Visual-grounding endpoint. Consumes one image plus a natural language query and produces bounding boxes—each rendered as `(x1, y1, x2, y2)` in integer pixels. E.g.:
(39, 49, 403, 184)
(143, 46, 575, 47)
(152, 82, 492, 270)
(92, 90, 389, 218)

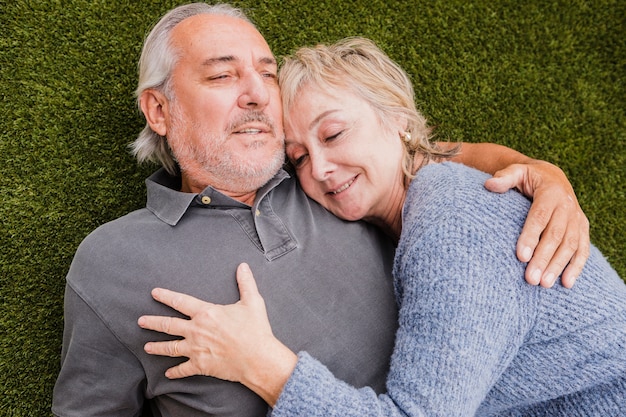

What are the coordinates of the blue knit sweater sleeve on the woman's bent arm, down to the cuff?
(273, 164, 533, 417)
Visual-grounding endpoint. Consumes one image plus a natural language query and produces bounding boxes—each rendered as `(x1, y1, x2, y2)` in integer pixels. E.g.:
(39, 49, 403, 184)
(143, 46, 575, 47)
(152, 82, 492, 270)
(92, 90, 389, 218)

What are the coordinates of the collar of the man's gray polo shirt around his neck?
(146, 168, 290, 226)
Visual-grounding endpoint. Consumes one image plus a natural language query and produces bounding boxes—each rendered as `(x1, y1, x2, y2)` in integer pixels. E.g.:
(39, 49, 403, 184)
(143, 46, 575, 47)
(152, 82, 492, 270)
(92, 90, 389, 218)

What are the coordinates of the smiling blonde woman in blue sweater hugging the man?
(140, 38, 626, 416)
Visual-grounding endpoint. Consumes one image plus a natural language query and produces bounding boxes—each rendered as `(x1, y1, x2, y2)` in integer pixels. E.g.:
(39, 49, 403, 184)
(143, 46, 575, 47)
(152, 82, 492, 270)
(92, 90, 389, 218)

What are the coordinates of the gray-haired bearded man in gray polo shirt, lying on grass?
(53, 4, 586, 417)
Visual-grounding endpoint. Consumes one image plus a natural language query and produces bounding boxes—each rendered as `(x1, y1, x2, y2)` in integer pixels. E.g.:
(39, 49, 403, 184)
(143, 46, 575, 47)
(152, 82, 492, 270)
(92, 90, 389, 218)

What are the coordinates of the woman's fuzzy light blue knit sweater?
(272, 163, 626, 417)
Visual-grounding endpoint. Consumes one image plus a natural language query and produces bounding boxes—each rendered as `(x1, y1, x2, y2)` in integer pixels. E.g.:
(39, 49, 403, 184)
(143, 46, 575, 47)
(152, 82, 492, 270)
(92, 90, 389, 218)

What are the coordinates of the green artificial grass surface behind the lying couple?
(0, 0, 626, 416)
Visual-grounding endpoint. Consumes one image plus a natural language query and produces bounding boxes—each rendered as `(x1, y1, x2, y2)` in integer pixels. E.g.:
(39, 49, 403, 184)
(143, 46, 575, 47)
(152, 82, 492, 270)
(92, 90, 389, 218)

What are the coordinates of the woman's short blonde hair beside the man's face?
(279, 37, 457, 184)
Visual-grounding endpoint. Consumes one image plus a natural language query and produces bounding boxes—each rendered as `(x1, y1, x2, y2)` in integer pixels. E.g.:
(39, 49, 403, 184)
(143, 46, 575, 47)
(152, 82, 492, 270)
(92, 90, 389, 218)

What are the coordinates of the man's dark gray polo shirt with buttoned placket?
(53, 170, 397, 417)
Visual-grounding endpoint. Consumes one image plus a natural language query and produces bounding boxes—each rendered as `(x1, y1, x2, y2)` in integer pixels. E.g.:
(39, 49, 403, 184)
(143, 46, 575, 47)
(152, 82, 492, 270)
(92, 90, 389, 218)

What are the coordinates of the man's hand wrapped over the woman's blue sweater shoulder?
(485, 160, 590, 288)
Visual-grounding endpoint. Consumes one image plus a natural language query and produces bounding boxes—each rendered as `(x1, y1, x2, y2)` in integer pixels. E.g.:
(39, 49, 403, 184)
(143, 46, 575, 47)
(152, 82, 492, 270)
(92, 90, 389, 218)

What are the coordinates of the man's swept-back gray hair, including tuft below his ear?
(131, 3, 252, 174)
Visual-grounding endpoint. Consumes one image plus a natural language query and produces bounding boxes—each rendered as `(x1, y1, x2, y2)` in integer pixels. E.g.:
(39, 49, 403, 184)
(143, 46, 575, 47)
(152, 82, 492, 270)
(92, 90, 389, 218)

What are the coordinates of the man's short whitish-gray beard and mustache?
(168, 109, 285, 193)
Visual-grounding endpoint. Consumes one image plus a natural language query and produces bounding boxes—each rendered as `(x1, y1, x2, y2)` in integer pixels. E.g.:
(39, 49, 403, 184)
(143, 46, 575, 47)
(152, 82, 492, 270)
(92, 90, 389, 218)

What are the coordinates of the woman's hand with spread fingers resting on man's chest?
(138, 264, 297, 406)
